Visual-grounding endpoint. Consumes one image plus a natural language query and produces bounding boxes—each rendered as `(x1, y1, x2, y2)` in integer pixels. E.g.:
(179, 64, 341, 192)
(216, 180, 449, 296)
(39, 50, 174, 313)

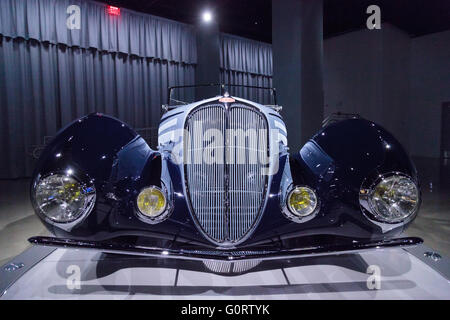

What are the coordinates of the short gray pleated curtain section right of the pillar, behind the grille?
(220, 34, 274, 104)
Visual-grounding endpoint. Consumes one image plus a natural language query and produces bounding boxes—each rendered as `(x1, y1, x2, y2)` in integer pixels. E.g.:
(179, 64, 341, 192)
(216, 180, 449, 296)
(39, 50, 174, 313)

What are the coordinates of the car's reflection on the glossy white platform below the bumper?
(48, 249, 415, 296)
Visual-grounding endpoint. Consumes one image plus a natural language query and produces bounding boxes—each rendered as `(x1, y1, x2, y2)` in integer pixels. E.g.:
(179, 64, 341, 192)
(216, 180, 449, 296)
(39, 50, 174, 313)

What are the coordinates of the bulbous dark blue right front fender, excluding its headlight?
(292, 119, 419, 238)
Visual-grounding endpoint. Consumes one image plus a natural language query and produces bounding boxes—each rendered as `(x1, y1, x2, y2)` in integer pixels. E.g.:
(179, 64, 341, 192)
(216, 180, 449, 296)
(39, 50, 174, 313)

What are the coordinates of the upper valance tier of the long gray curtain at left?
(0, 0, 197, 64)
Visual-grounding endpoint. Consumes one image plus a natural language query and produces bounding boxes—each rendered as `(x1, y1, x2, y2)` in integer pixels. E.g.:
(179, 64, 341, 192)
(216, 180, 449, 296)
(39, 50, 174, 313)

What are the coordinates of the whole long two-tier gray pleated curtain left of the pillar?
(0, 0, 196, 178)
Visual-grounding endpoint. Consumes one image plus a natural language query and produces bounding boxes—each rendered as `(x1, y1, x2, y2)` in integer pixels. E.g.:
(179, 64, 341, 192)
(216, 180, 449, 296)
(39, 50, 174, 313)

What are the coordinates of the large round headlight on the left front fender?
(34, 174, 95, 223)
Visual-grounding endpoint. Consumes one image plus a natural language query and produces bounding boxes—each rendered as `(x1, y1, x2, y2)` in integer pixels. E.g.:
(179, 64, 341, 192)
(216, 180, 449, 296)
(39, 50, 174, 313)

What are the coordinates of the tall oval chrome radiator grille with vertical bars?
(184, 104, 268, 243)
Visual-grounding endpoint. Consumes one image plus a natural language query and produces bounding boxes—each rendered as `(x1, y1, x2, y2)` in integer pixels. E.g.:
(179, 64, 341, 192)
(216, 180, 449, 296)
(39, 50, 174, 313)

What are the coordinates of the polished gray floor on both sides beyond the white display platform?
(0, 158, 450, 265)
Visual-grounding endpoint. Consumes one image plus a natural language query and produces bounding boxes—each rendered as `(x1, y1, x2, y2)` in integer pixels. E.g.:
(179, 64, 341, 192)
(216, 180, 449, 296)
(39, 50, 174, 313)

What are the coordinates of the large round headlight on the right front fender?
(369, 175, 419, 223)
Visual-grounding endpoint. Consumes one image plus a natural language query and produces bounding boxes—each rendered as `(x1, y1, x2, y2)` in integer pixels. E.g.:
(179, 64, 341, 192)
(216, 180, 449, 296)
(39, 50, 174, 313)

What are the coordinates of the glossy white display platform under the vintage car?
(0, 245, 450, 299)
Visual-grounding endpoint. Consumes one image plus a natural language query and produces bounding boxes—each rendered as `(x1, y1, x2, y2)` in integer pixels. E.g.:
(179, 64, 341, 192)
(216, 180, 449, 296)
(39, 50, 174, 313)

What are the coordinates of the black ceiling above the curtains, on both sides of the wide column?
(100, 0, 450, 42)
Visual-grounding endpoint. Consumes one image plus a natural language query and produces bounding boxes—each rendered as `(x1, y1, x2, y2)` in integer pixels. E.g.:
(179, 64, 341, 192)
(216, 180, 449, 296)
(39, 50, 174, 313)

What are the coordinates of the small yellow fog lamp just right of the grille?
(287, 187, 317, 217)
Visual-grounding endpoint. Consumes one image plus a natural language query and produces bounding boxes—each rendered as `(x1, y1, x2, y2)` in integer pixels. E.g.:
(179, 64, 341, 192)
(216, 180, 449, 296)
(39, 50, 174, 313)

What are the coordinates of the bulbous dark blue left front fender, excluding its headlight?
(31, 113, 161, 238)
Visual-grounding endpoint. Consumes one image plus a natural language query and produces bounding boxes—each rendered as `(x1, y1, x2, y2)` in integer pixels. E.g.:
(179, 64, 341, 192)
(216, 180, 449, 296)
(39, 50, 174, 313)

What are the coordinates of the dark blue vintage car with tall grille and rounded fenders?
(30, 86, 422, 260)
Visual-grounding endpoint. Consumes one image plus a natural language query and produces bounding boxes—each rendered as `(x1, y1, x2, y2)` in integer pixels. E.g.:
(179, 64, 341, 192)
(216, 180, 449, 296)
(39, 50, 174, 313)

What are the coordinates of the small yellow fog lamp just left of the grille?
(137, 186, 167, 218)
